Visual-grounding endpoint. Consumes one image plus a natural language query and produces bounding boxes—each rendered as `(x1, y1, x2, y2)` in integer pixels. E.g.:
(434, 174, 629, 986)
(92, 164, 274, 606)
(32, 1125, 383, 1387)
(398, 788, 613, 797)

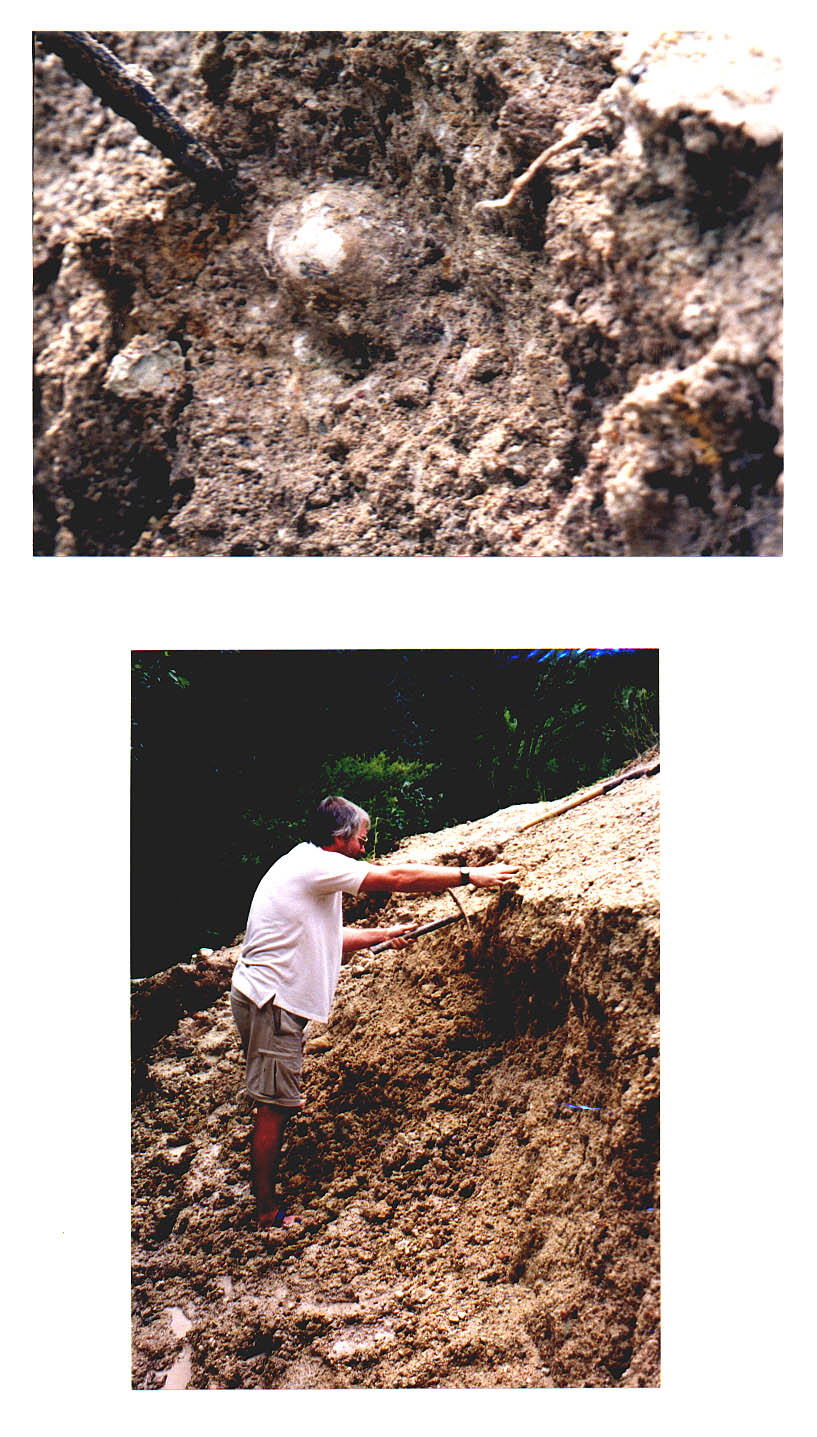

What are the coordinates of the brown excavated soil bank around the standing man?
(134, 776, 659, 1388)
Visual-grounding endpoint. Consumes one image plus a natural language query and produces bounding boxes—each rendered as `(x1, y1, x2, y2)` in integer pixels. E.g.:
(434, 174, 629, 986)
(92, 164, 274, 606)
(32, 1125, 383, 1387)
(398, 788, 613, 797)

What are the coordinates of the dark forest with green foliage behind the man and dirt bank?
(131, 650, 658, 977)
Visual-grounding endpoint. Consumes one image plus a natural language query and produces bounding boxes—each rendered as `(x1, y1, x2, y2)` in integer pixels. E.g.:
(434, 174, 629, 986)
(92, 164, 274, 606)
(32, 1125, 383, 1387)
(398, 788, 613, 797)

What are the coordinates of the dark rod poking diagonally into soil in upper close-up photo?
(34, 30, 241, 210)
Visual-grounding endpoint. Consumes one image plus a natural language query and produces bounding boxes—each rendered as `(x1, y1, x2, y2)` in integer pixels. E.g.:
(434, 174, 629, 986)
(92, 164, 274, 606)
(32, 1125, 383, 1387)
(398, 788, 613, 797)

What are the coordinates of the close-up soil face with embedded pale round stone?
(34, 32, 783, 556)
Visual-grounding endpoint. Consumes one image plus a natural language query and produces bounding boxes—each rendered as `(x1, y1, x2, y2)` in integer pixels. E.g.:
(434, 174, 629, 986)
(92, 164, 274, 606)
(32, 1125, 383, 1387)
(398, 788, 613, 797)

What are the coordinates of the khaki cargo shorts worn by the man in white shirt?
(230, 989, 307, 1109)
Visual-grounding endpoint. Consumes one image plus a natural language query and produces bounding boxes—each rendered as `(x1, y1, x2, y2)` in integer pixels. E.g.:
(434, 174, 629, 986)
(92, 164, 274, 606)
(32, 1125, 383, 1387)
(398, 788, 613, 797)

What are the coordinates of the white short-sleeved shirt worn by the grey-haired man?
(233, 844, 369, 1023)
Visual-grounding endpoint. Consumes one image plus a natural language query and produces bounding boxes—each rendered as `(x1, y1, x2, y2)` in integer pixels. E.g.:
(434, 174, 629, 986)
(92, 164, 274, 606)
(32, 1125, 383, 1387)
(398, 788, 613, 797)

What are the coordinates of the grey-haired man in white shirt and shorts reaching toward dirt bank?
(230, 798, 517, 1230)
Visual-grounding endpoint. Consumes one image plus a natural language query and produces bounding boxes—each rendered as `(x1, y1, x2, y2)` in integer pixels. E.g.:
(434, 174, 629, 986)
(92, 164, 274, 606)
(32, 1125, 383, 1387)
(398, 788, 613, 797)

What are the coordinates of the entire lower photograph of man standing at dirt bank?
(131, 648, 660, 1390)
